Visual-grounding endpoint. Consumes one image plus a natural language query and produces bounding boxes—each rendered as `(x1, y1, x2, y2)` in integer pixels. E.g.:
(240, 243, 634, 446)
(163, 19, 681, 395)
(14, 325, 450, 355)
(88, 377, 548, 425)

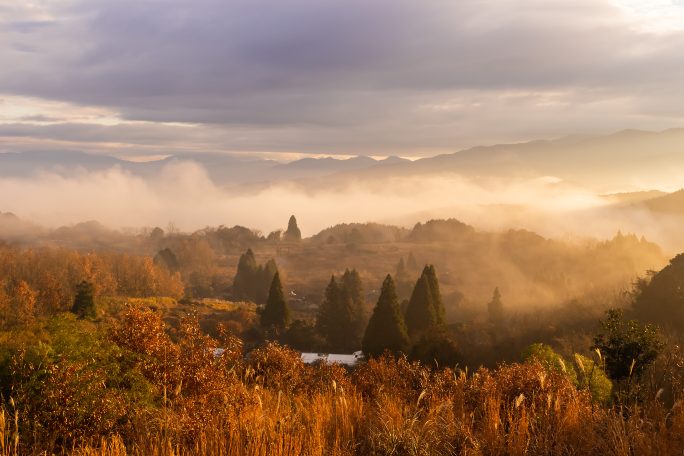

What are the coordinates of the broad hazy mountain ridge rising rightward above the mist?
(338, 129, 684, 192)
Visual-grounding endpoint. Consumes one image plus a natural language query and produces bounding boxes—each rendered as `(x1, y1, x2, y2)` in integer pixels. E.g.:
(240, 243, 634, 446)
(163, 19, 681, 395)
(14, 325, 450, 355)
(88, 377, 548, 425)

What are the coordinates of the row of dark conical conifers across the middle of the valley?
(233, 249, 460, 362)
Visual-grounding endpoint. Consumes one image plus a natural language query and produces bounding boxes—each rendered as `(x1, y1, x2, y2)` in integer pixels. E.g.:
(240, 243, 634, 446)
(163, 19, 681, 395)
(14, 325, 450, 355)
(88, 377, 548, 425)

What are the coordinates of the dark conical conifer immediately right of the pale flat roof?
(362, 274, 410, 356)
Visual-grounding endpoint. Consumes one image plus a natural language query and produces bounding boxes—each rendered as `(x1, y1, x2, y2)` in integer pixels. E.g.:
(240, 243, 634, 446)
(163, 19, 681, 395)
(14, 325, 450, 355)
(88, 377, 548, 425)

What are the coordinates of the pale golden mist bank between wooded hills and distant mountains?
(0, 161, 684, 251)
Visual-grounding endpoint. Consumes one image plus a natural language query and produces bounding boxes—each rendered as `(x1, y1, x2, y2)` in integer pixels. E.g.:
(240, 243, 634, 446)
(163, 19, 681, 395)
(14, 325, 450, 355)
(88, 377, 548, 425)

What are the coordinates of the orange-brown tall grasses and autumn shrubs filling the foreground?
(0, 309, 684, 456)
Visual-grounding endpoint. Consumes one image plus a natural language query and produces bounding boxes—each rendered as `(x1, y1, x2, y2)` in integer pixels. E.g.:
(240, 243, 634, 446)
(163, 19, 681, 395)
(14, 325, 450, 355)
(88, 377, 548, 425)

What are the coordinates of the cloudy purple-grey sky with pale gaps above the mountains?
(0, 0, 684, 157)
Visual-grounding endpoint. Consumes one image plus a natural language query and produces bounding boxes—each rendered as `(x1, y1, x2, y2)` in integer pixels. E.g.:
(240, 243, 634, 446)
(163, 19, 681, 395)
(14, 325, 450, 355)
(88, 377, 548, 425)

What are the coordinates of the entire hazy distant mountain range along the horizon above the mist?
(0, 129, 684, 193)
